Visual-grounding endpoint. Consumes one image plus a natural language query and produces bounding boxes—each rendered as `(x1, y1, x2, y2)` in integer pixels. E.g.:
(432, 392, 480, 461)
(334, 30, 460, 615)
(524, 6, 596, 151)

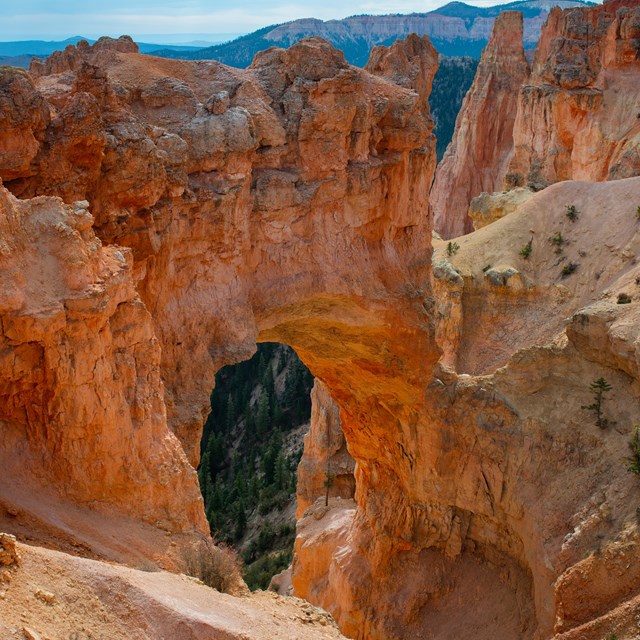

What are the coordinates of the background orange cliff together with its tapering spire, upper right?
(431, 0, 640, 238)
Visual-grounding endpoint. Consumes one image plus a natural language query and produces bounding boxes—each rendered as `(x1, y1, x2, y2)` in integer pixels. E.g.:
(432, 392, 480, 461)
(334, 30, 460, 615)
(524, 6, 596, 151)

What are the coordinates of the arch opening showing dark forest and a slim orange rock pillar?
(198, 343, 355, 593)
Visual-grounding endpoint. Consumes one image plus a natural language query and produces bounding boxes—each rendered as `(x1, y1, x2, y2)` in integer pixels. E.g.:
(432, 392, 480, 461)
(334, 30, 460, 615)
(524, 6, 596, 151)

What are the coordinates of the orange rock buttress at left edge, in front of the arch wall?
(0, 181, 206, 560)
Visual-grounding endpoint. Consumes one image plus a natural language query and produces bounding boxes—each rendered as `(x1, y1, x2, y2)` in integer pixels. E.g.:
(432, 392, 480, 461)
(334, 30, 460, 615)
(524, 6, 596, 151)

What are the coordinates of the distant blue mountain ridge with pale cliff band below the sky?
(155, 0, 593, 67)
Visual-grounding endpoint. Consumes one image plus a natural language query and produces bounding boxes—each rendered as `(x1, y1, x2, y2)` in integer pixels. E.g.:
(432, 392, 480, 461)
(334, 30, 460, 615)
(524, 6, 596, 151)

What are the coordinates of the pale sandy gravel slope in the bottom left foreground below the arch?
(0, 545, 344, 640)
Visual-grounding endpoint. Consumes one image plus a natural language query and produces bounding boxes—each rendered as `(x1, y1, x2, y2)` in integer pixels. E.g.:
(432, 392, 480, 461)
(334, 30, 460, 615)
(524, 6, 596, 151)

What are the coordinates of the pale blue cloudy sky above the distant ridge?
(0, 0, 499, 41)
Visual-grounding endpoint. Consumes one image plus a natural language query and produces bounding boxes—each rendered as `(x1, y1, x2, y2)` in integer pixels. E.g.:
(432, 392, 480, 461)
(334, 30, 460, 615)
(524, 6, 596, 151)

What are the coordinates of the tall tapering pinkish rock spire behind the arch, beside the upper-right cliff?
(431, 11, 529, 238)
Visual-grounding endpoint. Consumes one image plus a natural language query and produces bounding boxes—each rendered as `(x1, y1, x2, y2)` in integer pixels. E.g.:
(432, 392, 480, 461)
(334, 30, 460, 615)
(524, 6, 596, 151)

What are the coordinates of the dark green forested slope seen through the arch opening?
(198, 343, 313, 589)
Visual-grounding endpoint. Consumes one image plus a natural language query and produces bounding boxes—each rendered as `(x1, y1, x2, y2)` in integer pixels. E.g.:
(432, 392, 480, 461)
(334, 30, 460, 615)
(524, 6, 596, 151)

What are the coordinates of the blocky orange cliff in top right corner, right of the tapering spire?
(509, 0, 640, 188)
